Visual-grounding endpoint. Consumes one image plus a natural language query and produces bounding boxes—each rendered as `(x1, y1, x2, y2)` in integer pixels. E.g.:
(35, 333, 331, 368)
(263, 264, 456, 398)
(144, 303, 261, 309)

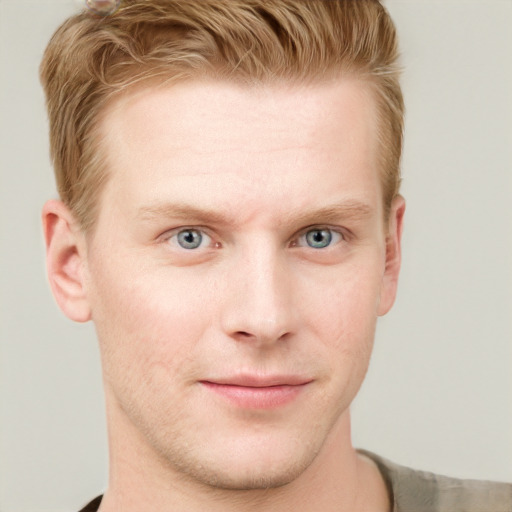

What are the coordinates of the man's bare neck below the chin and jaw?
(100, 404, 389, 512)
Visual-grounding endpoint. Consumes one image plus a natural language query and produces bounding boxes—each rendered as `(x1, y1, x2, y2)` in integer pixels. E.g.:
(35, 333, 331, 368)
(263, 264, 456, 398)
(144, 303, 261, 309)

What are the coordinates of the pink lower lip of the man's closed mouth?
(201, 382, 306, 409)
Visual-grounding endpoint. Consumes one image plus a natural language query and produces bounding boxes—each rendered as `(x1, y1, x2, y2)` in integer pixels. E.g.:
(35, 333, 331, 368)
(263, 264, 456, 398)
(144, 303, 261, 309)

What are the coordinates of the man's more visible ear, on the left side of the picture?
(42, 200, 91, 322)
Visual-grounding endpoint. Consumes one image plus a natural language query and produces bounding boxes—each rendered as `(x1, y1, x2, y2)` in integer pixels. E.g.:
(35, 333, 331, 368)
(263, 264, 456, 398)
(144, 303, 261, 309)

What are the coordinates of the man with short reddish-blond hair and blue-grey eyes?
(41, 0, 512, 512)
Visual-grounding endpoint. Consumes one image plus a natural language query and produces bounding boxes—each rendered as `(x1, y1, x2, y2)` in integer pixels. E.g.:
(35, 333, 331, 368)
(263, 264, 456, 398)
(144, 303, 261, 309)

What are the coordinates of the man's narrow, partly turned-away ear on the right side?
(377, 196, 405, 316)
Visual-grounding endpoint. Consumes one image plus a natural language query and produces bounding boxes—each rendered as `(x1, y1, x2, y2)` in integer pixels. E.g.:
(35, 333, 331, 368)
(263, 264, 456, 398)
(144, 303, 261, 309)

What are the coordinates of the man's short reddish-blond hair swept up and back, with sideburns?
(41, 0, 404, 230)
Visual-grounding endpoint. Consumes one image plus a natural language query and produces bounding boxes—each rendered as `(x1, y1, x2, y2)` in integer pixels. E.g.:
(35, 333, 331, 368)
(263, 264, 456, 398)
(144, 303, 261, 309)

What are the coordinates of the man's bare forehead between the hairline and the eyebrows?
(98, 79, 381, 222)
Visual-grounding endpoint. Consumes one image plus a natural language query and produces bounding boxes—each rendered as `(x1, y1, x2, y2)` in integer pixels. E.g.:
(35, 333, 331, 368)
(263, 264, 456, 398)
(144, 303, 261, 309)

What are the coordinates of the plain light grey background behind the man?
(0, 0, 512, 512)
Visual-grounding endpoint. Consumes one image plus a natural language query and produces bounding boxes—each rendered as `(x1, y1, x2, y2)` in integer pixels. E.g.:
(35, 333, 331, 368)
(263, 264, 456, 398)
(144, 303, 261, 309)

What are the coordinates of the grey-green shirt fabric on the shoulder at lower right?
(360, 450, 512, 512)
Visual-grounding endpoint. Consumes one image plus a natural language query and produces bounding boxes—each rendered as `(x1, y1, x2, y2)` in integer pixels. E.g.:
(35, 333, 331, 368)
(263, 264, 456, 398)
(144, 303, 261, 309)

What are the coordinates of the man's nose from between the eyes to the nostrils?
(222, 242, 297, 345)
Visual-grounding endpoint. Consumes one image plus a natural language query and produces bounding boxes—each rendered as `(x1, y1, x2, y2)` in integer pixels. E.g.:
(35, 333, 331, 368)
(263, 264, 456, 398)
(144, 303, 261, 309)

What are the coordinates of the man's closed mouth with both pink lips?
(200, 375, 312, 409)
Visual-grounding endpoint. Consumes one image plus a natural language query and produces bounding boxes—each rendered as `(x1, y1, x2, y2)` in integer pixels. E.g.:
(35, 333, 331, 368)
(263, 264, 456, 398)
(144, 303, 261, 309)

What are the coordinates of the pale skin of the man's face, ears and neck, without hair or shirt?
(43, 79, 405, 512)
